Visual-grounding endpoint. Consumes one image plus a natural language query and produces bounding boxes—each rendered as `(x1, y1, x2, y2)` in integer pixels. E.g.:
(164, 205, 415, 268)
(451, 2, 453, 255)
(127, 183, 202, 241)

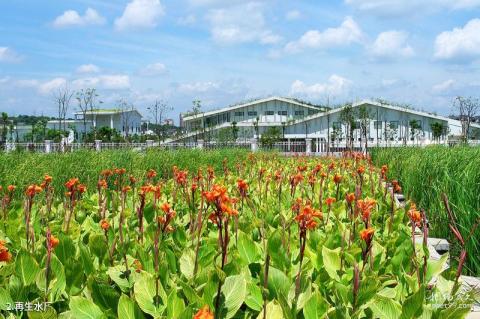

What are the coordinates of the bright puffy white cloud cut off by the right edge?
(435, 19, 480, 60)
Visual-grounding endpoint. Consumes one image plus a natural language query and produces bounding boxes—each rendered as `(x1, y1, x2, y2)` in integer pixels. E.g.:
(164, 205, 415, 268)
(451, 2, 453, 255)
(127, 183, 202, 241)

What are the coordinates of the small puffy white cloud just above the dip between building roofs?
(290, 74, 352, 99)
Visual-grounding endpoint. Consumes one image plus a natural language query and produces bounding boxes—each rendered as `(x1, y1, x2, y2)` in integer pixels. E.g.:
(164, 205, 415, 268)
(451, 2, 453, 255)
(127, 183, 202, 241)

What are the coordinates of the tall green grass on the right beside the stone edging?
(372, 146, 480, 275)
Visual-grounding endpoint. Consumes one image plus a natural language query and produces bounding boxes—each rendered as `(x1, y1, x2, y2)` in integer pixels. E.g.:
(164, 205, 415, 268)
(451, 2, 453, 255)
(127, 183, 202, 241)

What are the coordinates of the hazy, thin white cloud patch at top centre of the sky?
(207, 2, 281, 44)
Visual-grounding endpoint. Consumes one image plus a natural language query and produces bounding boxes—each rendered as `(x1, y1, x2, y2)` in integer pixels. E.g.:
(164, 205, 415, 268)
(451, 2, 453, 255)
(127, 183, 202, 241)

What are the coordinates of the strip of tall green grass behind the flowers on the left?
(0, 149, 248, 190)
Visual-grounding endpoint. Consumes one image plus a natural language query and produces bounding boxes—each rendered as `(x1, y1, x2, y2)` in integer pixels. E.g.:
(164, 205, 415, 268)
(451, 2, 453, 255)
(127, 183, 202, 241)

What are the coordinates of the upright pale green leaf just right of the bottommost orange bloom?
(221, 275, 247, 319)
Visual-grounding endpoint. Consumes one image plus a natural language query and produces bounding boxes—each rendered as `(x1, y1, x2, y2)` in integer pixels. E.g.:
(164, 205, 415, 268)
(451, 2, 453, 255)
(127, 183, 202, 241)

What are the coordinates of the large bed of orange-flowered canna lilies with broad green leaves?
(0, 153, 477, 319)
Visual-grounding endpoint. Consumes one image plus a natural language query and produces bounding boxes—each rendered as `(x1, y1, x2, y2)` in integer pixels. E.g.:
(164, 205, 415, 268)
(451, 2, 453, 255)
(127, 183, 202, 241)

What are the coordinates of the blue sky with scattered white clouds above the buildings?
(0, 0, 480, 120)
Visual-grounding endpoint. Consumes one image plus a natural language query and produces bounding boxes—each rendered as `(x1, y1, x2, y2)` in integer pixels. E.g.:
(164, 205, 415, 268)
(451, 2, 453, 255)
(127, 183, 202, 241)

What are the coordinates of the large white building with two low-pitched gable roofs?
(178, 97, 480, 145)
